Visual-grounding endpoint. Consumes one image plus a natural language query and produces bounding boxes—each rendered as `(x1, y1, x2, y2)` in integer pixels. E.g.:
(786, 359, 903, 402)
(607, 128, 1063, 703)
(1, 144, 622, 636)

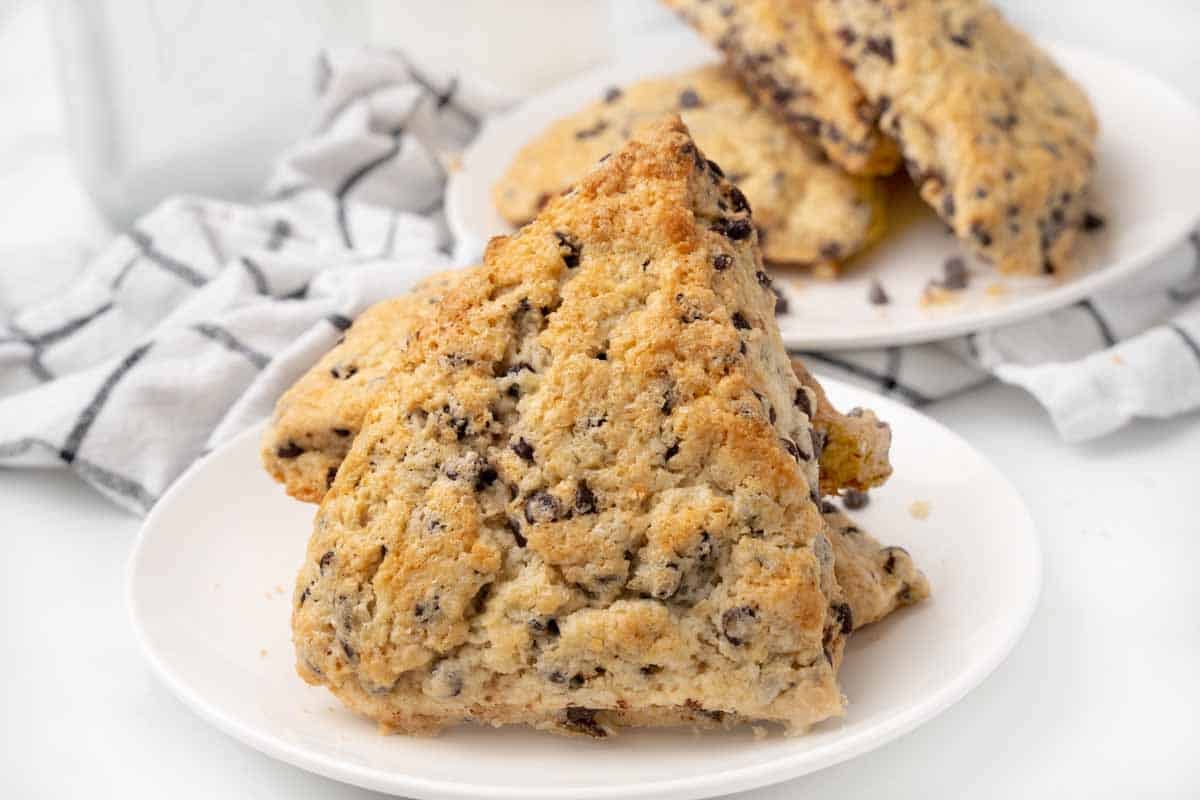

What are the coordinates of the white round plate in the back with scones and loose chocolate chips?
(446, 35, 1200, 350)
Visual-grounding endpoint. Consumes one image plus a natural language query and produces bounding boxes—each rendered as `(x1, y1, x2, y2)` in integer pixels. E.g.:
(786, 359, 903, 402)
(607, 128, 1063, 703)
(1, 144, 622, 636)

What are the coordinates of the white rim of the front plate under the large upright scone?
(125, 381, 1044, 800)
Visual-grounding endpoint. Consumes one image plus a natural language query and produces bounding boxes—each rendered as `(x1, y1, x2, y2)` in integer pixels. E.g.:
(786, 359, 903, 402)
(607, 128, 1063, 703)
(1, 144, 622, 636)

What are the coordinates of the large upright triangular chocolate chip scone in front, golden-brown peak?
(293, 119, 851, 736)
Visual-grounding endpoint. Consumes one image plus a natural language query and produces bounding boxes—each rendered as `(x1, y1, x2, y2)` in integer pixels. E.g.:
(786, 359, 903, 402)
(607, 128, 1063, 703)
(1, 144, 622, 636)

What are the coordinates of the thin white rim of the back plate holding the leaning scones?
(445, 37, 1200, 350)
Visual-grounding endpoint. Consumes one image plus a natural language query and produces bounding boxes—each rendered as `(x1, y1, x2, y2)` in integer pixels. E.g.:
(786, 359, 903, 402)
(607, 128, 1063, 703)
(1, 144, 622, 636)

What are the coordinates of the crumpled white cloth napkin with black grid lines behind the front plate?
(0, 50, 1200, 513)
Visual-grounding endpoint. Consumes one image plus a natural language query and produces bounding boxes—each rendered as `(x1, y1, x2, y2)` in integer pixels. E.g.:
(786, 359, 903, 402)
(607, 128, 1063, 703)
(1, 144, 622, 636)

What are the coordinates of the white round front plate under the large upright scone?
(128, 380, 1042, 800)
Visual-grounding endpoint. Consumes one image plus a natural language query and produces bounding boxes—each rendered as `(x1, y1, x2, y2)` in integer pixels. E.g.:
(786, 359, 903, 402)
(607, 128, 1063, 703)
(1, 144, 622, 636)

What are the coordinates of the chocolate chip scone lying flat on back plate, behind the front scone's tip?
(492, 66, 883, 267)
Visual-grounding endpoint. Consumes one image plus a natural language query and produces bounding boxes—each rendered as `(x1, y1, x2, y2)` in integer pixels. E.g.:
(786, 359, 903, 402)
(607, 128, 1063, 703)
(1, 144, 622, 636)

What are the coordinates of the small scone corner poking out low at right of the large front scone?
(822, 501, 929, 630)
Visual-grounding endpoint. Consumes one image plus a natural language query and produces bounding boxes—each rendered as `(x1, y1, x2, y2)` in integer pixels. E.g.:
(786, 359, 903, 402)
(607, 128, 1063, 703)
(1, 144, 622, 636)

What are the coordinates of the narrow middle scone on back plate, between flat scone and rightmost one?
(664, 0, 900, 175)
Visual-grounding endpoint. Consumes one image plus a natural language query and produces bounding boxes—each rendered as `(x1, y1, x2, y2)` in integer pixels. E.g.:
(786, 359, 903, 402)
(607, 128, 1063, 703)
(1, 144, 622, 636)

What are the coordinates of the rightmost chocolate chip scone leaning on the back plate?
(816, 0, 1097, 275)
